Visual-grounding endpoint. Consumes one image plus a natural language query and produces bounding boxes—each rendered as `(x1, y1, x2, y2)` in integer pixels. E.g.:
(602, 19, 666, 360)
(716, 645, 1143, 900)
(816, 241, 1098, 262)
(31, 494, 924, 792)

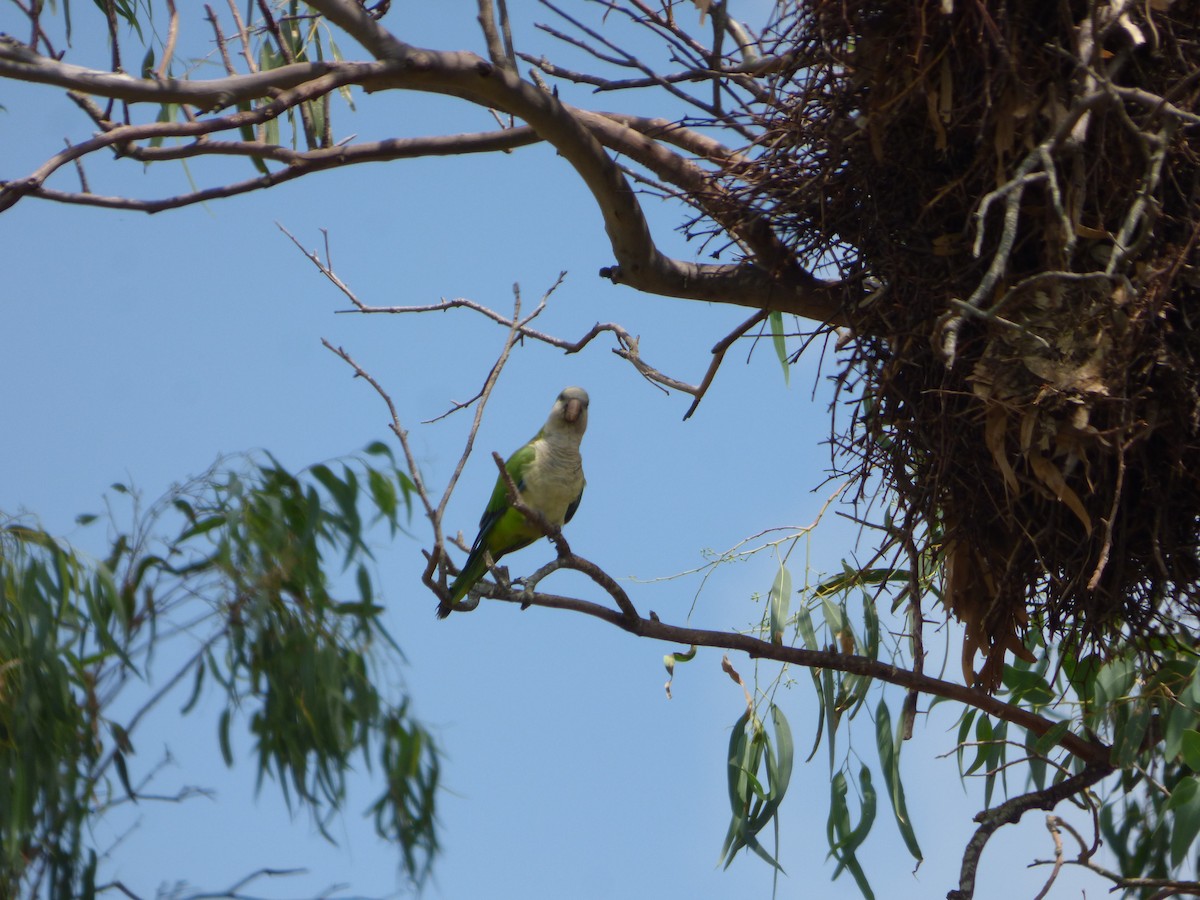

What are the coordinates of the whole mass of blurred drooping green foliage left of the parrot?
(0, 444, 439, 896)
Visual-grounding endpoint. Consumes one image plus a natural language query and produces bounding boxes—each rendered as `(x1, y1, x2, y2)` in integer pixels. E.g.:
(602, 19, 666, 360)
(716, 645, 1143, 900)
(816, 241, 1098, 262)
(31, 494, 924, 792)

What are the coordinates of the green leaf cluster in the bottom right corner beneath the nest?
(958, 638, 1200, 898)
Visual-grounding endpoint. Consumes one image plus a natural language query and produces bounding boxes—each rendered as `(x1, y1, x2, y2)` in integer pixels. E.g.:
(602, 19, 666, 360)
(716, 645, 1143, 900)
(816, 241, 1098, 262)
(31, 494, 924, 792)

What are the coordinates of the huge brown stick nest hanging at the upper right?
(752, 0, 1200, 688)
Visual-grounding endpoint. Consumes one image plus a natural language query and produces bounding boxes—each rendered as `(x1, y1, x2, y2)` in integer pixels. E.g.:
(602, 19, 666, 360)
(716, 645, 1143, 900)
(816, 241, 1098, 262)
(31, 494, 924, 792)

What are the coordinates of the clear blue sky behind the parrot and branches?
(0, 0, 1106, 900)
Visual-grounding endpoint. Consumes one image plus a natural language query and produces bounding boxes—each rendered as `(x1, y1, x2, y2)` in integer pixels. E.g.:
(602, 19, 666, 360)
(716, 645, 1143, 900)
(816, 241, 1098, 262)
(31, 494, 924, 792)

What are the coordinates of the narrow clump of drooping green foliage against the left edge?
(0, 524, 112, 896)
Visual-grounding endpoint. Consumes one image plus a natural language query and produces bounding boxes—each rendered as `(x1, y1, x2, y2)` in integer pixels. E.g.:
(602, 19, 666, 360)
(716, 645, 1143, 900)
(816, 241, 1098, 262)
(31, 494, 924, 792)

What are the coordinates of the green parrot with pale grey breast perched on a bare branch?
(438, 388, 588, 619)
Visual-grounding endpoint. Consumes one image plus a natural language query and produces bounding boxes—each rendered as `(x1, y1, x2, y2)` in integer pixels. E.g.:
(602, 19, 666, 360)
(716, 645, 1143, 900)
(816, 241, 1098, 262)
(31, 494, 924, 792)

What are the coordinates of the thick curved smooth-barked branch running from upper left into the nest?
(0, 0, 841, 323)
